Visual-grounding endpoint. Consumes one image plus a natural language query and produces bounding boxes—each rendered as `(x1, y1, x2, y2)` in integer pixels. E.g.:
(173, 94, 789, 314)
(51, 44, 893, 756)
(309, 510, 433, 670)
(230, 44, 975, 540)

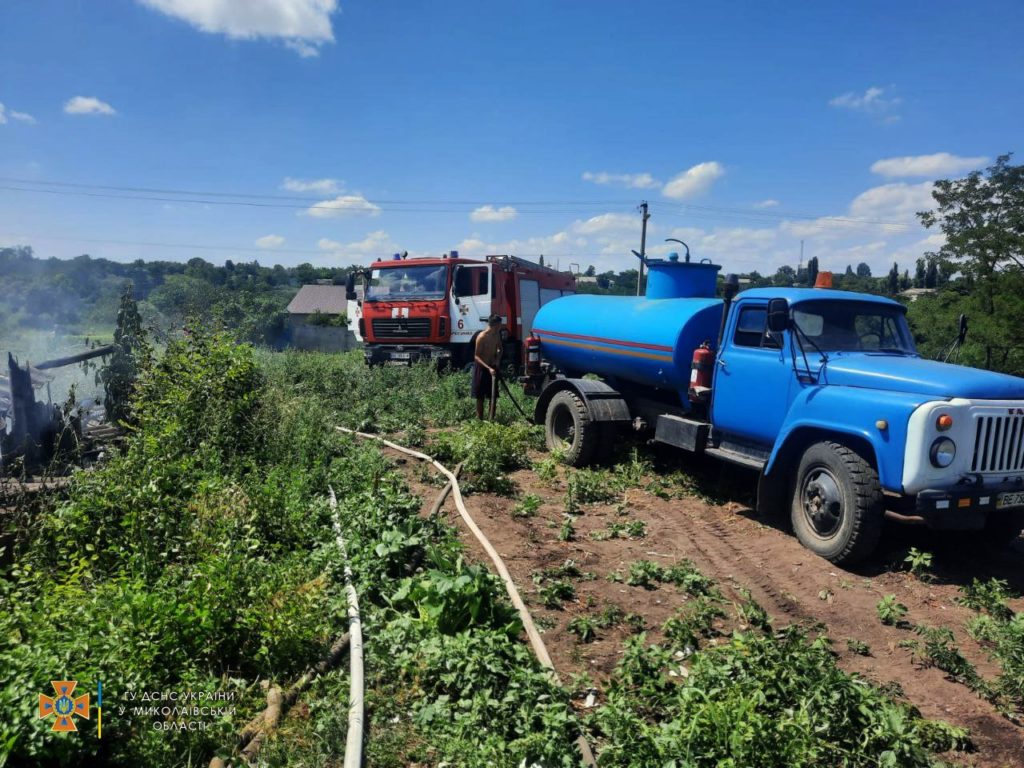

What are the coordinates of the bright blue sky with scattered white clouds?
(0, 0, 1024, 272)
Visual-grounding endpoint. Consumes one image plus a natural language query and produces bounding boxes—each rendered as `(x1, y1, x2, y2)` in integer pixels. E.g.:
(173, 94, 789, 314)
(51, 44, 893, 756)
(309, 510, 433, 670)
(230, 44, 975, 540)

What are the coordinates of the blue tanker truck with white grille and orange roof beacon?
(524, 254, 1024, 563)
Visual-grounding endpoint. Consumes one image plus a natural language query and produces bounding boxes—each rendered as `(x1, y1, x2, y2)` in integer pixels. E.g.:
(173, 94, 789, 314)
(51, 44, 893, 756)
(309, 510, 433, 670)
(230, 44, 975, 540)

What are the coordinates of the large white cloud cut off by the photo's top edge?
(137, 0, 338, 57)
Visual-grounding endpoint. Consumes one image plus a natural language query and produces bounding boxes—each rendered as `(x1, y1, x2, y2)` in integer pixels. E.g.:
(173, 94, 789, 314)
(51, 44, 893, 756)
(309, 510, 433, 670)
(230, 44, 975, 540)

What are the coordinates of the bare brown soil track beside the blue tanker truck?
(395, 455, 1024, 768)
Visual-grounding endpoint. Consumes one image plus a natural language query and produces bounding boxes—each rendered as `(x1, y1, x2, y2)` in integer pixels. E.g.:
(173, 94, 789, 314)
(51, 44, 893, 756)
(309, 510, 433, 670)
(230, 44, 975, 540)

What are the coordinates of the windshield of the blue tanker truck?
(793, 301, 916, 354)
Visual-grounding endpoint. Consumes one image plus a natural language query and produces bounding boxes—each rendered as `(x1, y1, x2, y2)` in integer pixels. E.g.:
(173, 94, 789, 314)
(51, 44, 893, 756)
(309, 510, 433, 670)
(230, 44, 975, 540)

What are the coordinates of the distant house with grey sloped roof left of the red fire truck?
(287, 285, 359, 352)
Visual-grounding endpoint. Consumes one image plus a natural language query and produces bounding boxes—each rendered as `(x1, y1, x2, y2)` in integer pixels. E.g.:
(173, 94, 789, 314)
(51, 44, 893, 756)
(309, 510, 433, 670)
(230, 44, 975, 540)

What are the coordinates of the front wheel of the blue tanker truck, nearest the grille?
(791, 441, 885, 565)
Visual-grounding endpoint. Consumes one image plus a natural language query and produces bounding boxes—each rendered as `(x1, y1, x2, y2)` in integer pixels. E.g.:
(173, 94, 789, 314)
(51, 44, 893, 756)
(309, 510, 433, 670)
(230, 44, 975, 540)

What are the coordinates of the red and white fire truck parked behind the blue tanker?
(347, 251, 575, 369)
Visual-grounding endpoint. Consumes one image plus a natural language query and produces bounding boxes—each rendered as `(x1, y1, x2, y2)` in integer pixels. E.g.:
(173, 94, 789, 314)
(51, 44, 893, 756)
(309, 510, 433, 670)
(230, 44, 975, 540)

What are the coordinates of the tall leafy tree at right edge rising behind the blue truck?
(918, 155, 1024, 373)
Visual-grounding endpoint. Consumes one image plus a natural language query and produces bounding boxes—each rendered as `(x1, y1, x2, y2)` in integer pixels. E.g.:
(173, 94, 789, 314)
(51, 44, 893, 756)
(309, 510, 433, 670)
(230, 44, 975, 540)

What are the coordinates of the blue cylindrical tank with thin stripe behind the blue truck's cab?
(534, 295, 723, 397)
